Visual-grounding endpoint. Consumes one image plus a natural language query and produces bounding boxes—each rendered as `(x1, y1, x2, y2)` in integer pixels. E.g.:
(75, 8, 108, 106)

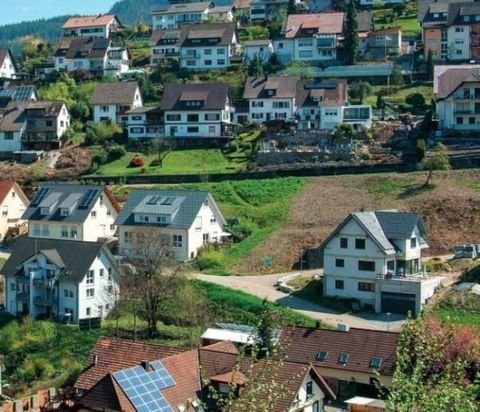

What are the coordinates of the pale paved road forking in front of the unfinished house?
(193, 270, 405, 330)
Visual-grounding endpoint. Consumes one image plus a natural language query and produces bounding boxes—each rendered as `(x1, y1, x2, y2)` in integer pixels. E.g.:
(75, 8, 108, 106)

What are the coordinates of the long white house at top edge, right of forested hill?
(152, 2, 214, 30)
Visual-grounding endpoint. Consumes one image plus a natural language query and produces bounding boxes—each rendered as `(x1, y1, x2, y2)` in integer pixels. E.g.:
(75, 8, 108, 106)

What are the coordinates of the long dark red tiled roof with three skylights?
(280, 326, 399, 376)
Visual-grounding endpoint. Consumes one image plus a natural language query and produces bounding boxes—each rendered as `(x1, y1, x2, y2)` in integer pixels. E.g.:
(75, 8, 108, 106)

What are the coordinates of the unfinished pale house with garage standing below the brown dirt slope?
(321, 210, 441, 315)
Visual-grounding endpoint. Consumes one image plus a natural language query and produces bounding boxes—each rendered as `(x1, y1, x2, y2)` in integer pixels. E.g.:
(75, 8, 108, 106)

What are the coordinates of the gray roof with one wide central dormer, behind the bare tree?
(115, 189, 225, 229)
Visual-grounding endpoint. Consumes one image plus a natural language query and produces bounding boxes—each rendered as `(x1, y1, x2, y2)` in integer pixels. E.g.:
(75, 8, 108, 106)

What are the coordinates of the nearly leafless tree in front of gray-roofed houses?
(127, 226, 181, 338)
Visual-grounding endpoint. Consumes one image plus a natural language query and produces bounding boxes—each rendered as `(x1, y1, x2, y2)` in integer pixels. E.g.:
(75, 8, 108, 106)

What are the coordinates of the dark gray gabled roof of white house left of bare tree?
(1, 237, 109, 282)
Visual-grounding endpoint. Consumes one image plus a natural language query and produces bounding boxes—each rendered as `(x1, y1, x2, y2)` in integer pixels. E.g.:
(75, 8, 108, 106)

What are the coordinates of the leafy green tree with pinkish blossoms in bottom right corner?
(387, 316, 480, 412)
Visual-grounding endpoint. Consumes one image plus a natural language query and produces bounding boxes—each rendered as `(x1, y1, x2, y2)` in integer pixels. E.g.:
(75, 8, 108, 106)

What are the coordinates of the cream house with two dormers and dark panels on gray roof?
(22, 183, 119, 242)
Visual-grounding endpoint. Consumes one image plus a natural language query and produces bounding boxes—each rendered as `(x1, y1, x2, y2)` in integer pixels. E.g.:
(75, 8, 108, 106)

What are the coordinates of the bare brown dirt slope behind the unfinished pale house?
(234, 171, 480, 274)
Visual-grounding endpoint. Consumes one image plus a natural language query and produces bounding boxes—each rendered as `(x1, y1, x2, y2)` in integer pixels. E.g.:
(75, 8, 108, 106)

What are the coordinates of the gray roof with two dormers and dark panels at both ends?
(22, 183, 108, 222)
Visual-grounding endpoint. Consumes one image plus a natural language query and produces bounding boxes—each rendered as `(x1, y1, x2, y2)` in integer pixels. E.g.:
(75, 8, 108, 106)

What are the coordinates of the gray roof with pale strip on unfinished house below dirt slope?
(320, 210, 426, 254)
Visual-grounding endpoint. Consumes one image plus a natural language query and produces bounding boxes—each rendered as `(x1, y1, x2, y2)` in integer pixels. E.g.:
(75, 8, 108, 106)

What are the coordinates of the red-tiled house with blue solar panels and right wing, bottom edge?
(75, 337, 335, 412)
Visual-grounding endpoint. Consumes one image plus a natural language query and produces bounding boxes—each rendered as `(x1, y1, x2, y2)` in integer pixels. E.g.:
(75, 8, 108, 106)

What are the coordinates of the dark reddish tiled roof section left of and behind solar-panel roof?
(74, 337, 186, 390)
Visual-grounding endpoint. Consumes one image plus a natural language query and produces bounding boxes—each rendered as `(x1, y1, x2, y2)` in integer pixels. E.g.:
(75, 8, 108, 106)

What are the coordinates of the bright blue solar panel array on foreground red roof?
(113, 361, 175, 412)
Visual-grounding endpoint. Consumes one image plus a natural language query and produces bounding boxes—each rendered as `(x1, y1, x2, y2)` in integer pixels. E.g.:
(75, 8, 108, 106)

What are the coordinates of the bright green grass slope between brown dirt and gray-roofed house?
(114, 177, 304, 274)
